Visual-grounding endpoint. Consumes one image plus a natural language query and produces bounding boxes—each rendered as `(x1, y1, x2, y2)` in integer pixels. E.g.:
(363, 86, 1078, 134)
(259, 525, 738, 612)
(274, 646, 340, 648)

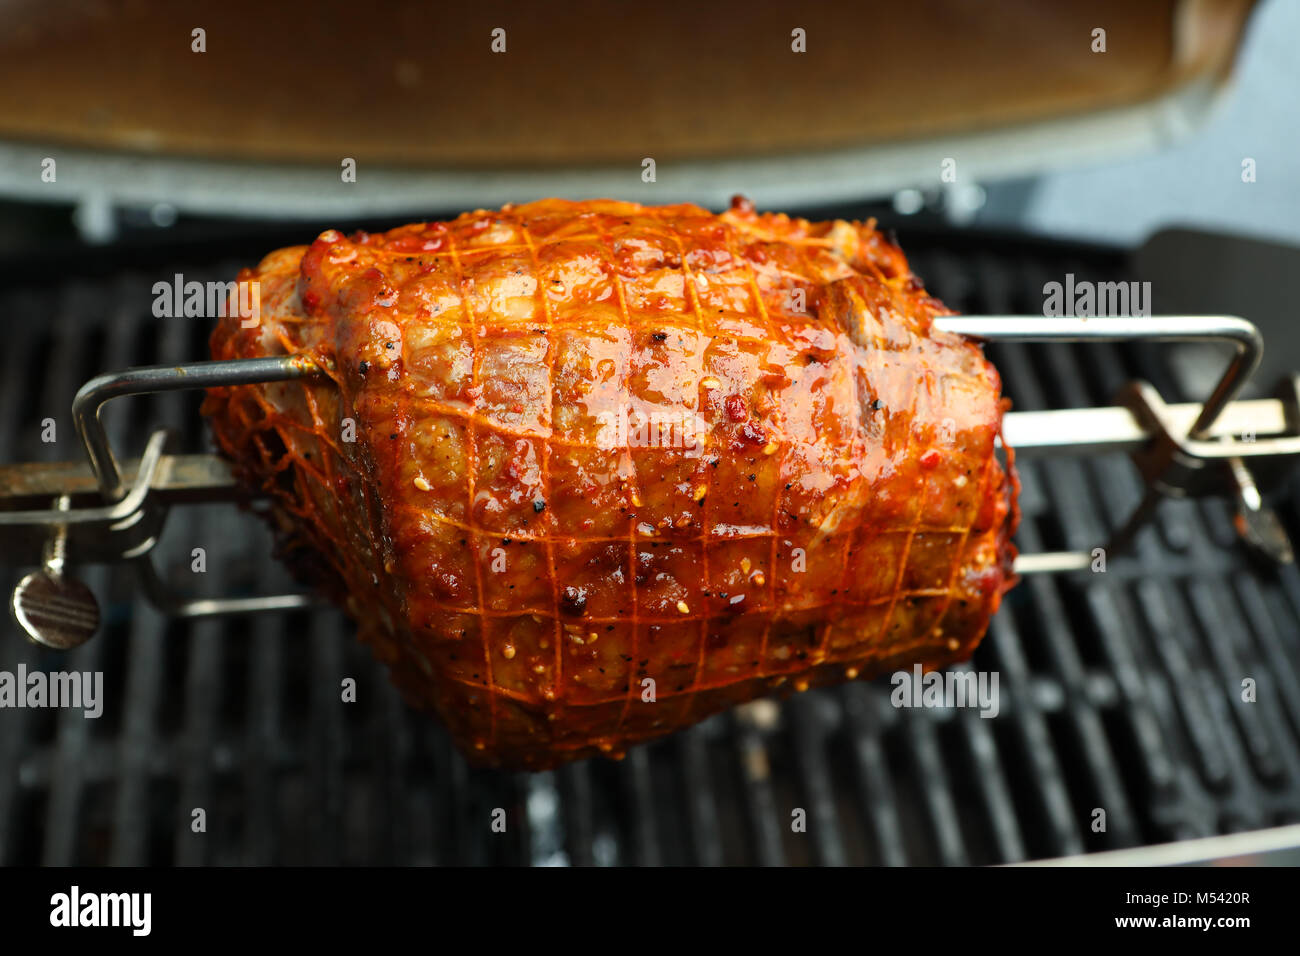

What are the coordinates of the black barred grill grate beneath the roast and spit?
(0, 226, 1300, 865)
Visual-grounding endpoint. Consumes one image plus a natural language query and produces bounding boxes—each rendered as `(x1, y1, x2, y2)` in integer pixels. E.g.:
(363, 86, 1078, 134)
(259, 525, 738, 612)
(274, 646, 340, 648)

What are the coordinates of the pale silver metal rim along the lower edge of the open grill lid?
(0, 77, 1226, 223)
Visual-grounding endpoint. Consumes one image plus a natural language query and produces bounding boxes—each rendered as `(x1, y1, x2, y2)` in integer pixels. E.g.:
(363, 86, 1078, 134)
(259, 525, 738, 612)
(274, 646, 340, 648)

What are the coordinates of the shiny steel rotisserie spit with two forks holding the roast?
(0, 316, 1300, 648)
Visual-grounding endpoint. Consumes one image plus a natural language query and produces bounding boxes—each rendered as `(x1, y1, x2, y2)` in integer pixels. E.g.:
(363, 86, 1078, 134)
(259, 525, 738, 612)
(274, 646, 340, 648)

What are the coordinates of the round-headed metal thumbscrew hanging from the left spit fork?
(9, 494, 99, 650)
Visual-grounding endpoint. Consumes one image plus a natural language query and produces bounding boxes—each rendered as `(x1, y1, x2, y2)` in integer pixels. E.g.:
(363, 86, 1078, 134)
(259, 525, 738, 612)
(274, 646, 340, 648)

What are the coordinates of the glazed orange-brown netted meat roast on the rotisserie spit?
(204, 200, 1018, 769)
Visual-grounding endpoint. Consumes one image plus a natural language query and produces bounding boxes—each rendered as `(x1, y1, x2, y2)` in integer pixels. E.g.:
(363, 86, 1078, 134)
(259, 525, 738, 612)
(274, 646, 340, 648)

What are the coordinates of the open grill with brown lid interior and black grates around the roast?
(0, 0, 1300, 874)
